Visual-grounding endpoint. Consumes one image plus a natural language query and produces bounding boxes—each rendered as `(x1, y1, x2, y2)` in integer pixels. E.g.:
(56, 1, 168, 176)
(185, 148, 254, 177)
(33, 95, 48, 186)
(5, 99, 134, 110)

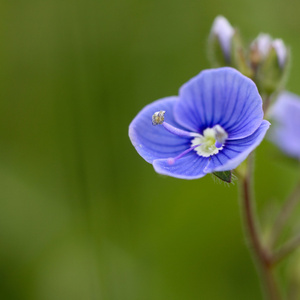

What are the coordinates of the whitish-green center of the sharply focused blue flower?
(192, 125, 228, 157)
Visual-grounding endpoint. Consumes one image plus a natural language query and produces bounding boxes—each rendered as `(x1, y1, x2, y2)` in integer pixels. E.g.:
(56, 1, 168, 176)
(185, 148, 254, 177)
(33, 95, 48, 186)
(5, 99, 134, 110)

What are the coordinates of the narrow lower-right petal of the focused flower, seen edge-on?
(204, 120, 270, 173)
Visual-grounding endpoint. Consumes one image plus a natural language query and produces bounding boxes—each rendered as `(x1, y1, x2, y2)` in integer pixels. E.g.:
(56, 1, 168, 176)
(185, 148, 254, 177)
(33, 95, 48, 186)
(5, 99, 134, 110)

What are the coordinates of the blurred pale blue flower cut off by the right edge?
(269, 92, 300, 159)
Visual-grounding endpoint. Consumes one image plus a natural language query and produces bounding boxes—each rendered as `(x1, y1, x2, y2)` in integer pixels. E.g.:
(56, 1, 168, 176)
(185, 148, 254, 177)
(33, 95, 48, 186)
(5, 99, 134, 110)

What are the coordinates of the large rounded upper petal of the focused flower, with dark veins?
(174, 68, 263, 139)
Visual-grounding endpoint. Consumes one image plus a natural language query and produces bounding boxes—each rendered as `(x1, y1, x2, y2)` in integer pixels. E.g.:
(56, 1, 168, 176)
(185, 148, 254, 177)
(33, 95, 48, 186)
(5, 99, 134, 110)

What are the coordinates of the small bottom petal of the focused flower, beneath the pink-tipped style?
(153, 151, 209, 179)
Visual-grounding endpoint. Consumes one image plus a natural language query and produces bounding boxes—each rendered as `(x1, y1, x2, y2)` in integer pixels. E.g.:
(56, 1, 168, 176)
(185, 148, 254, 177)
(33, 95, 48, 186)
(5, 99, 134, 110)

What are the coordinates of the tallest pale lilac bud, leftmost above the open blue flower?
(209, 16, 235, 66)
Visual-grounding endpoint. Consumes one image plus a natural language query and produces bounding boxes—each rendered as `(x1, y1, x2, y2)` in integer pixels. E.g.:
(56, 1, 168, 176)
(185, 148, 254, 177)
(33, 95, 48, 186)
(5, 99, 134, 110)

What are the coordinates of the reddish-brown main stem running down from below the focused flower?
(241, 154, 281, 300)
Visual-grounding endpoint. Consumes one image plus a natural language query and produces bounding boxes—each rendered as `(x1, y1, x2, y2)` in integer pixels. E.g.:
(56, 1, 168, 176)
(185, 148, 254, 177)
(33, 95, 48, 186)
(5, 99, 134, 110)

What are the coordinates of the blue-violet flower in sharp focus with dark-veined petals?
(129, 68, 270, 179)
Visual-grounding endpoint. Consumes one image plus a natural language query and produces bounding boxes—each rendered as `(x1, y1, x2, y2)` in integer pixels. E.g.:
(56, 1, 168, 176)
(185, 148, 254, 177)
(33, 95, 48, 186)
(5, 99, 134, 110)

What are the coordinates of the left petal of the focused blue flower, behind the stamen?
(129, 97, 190, 163)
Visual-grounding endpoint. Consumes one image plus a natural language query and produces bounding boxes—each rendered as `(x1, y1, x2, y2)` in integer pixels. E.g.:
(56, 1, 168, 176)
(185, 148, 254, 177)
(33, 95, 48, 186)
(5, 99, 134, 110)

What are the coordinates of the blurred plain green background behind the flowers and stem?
(0, 0, 300, 300)
